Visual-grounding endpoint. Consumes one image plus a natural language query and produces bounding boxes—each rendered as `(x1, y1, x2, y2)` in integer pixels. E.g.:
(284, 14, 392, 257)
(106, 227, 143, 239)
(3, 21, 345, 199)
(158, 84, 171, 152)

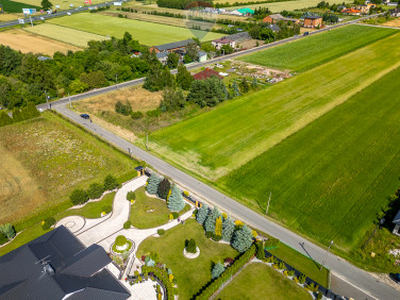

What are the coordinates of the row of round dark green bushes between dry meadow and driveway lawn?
(69, 175, 121, 205)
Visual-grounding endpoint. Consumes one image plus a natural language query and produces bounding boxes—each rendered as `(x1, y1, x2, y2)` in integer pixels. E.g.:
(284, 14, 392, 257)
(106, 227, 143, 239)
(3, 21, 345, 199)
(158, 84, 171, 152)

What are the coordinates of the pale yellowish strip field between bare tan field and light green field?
(25, 23, 108, 48)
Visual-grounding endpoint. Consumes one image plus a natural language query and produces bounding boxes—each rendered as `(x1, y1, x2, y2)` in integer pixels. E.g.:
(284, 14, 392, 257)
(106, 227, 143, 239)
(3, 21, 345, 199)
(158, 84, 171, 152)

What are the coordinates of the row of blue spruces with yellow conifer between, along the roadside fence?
(196, 204, 253, 252)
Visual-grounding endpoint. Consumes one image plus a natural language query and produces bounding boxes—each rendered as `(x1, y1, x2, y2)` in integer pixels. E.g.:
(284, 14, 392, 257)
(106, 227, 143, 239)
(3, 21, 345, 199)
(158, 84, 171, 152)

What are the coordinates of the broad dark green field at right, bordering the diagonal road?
(219, 68, 400, 251)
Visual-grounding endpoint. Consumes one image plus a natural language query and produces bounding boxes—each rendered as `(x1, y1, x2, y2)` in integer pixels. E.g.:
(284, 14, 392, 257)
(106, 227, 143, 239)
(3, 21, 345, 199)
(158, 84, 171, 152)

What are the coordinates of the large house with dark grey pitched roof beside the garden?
(0, 226, 130, 300)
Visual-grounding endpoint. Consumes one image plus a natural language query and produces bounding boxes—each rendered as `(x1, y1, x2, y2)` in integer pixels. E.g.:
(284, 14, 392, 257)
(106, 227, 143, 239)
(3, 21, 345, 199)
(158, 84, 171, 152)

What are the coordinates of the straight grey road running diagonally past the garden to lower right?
(53, 103, 400, 300)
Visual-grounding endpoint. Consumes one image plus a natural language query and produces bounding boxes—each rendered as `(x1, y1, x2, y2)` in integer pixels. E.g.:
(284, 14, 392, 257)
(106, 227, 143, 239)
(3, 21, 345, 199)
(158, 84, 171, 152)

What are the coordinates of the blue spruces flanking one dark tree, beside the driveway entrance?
(146, 172, 185, 212)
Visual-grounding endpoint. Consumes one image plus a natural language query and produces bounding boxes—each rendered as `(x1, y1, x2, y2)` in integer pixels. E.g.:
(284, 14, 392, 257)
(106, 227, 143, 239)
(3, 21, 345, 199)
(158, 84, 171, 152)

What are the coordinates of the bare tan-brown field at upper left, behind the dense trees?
(0, 29, 81, 55)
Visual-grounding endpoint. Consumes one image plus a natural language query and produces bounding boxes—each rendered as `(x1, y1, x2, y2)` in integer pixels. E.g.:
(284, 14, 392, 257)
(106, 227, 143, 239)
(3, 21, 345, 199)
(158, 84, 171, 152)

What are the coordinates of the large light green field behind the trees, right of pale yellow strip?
(49, 13, 222, 46)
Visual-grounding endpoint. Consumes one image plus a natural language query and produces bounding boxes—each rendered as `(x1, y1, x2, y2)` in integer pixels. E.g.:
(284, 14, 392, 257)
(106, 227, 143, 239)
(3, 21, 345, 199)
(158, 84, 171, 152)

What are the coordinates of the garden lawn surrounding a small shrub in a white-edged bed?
(136, 219, 239, 300)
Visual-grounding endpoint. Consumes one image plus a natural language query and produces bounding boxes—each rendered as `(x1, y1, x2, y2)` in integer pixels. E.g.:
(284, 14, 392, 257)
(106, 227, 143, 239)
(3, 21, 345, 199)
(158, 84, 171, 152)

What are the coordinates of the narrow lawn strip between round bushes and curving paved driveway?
(55, 192, 115, 221)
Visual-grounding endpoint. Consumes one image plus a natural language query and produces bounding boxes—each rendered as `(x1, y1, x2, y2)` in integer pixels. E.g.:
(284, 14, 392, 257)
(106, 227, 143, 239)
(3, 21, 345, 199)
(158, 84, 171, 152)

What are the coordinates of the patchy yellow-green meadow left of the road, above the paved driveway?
(0, 113, 135, 224)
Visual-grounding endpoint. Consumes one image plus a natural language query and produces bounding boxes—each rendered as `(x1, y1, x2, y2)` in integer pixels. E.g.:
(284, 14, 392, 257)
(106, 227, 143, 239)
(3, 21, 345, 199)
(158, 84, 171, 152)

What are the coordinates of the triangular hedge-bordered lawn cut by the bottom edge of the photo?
(216, 263, 312, 300)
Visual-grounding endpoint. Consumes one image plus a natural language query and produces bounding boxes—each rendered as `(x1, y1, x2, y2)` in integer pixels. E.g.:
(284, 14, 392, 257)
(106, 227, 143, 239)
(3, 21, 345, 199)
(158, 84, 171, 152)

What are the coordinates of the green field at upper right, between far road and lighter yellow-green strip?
(239, 25, 397, 72)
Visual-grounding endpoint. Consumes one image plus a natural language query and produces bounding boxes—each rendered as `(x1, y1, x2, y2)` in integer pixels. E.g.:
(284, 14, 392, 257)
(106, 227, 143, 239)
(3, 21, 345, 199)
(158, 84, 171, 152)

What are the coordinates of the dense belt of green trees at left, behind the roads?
(0, 32, 152, 109)
